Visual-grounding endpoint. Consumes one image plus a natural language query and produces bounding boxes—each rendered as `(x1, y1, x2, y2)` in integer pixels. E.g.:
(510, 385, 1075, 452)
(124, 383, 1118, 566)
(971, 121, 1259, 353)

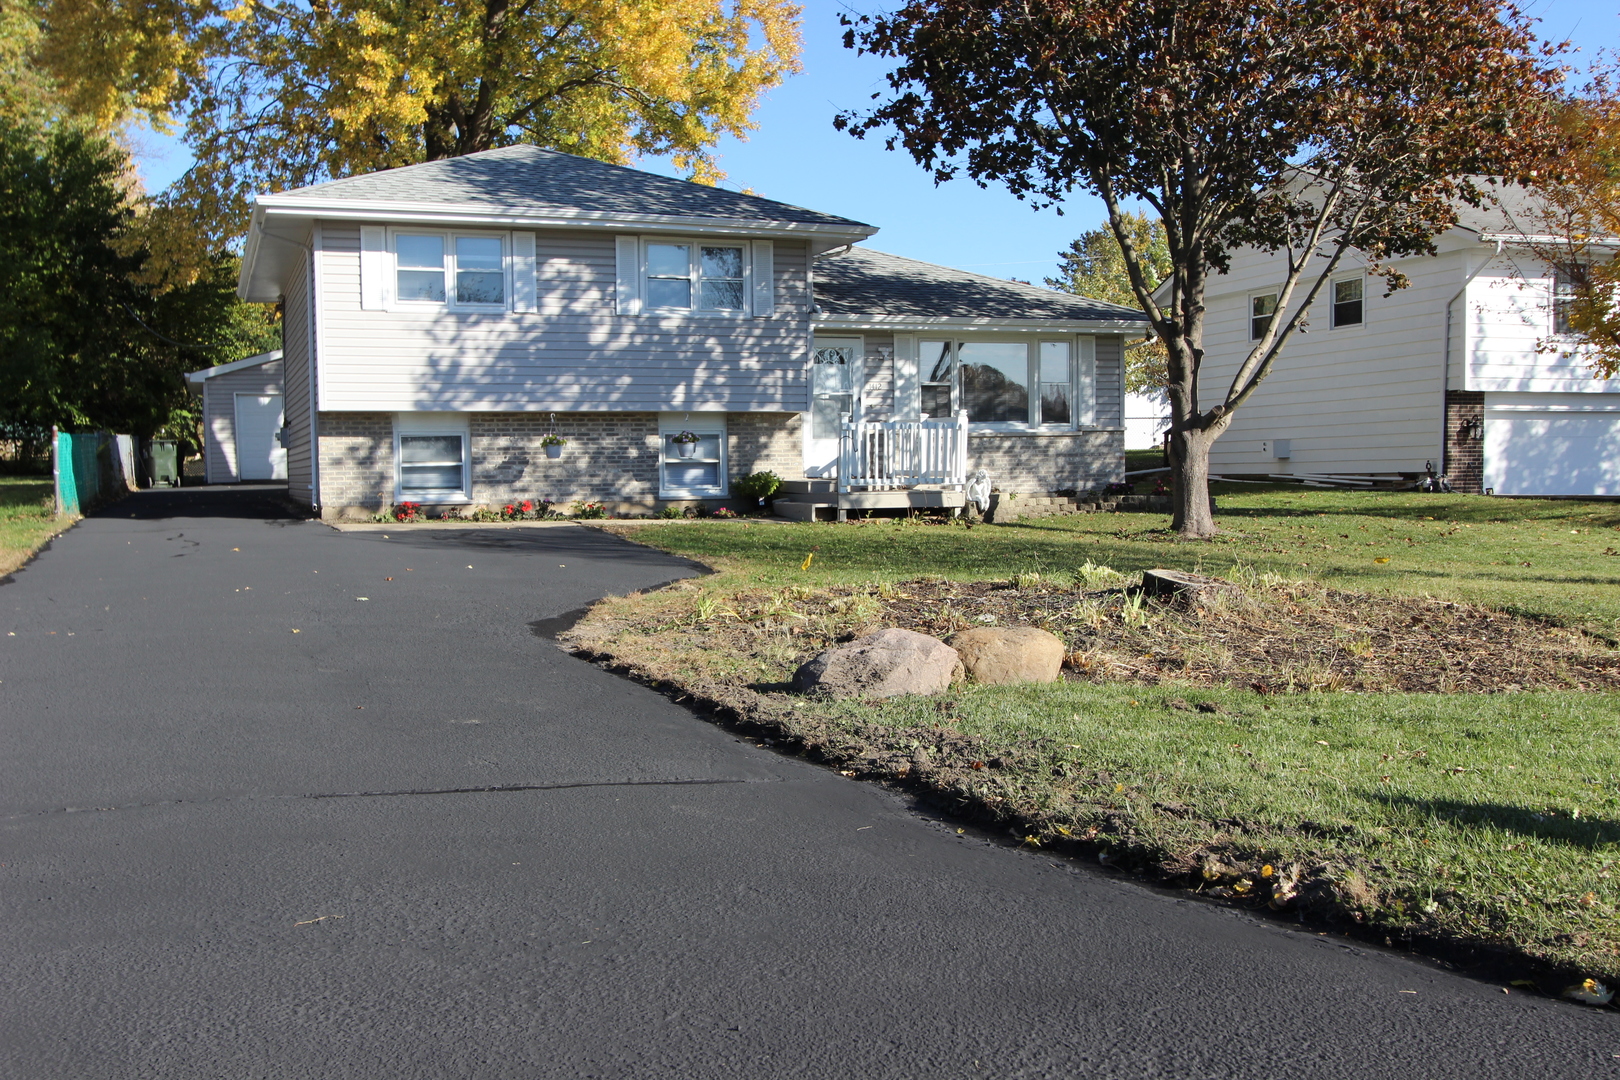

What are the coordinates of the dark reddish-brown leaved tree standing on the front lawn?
(836, 0, 1558, 538)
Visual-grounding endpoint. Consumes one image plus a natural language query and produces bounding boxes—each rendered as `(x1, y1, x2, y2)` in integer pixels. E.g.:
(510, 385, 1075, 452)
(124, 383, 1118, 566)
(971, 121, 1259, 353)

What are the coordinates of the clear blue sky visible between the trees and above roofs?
(136, 0, 1620, 283)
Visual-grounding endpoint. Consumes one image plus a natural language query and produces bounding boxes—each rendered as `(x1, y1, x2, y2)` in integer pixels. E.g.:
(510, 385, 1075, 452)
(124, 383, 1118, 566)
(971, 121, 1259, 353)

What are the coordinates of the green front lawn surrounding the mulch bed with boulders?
(582, 484, 1620, 984)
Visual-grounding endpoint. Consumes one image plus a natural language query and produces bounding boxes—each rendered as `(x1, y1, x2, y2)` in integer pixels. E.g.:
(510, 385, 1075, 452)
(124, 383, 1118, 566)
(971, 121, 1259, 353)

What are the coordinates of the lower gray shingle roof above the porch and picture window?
(815, 248, 1147, 322)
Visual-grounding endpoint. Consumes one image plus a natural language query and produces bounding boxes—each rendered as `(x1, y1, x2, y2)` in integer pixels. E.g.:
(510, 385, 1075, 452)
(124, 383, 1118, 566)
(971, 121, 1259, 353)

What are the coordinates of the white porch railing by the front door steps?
(838, 413, 967, 492)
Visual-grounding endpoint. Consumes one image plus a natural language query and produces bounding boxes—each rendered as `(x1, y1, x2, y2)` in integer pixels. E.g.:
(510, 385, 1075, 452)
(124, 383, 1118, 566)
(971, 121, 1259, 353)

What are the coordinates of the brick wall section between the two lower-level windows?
(470, 413, 658, 513)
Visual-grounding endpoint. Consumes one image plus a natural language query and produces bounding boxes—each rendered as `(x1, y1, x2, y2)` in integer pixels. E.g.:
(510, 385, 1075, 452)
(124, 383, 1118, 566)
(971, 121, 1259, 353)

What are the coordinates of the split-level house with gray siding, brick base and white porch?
(238, 146, 1144, 517)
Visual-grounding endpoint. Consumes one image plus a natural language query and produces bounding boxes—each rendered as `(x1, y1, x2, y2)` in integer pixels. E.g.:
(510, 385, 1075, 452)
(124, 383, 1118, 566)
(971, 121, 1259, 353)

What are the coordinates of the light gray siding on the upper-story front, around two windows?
(319, 225, 810, 413)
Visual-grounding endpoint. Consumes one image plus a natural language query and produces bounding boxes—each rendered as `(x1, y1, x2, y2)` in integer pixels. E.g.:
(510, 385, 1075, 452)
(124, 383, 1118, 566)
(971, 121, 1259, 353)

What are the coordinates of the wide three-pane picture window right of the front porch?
(919, 340, 1090, 429)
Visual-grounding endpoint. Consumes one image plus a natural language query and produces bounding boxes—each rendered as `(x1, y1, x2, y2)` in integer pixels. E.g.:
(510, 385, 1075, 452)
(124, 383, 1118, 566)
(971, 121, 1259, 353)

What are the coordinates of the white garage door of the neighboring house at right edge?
(1484, 408, 1620, 495)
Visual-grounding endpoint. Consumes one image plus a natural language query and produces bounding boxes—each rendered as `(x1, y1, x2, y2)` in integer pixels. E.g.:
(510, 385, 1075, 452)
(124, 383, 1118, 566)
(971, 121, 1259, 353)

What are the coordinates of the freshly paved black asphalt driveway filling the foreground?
(0, 489, 1620, 1080)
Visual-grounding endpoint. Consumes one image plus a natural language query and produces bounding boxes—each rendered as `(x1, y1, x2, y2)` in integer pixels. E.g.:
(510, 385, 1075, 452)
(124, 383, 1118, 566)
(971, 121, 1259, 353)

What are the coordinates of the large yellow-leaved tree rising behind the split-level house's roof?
(36, 0, 799, 257)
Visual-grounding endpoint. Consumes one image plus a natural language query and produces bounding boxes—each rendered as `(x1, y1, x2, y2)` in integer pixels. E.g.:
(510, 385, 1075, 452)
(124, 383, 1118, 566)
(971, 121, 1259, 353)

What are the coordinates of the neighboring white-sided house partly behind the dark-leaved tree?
(1200, 193, 1620, 495)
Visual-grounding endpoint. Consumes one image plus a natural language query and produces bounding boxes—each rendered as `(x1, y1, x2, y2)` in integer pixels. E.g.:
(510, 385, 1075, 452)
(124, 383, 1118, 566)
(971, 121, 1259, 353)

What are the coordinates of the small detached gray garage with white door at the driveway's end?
(186, 350, 287, 484)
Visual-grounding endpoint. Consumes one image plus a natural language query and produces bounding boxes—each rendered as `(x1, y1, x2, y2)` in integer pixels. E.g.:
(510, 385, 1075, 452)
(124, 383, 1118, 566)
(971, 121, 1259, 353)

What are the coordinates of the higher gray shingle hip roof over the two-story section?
(277, 146, 870, 228)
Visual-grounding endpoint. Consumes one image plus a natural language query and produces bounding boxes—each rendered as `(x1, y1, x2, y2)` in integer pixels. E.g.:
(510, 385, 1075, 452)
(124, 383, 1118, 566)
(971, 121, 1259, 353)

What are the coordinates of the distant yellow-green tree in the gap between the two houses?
(1047, 210, 1170, 395)
